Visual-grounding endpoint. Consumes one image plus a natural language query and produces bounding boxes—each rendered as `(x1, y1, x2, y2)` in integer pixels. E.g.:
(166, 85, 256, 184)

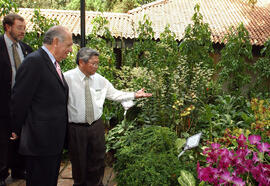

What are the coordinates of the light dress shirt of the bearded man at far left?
(4, 34, 24, 87)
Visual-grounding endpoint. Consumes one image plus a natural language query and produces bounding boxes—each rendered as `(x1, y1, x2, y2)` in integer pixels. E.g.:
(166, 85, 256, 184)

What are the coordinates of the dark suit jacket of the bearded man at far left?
(0, 35, 33, 120)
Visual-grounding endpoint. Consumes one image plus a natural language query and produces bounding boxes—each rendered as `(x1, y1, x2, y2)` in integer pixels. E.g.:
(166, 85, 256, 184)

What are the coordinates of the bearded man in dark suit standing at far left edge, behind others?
(0, 14, 33, 186)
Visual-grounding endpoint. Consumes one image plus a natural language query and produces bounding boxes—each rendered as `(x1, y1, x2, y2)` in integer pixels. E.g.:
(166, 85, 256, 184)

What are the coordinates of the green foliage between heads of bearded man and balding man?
(24, 10, 59, 50)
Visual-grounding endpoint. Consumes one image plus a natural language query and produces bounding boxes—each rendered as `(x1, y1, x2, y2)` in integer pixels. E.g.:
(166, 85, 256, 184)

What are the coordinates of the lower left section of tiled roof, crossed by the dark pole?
(16, 8, 134, 38)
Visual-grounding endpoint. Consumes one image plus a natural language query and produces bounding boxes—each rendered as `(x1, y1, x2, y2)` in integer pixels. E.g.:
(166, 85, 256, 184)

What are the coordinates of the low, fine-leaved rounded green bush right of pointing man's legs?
(114, 126, 184, 186)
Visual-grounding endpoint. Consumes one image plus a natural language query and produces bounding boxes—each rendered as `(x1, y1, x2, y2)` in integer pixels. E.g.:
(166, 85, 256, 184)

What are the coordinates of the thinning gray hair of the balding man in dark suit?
(43, 25, 68, 45)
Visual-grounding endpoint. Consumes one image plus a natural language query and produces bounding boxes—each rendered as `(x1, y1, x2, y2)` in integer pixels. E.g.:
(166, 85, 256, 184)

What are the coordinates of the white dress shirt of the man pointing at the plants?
(64, 67, 135, 123)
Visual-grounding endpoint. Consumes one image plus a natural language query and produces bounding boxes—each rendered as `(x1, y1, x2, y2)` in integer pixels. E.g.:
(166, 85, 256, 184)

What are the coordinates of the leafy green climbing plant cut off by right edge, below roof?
(254, 39, 270, 94)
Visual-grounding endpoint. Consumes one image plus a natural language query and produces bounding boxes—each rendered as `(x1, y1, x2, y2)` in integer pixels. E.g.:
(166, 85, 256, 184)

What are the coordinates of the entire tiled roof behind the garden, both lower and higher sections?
(5, 0, 270, 45)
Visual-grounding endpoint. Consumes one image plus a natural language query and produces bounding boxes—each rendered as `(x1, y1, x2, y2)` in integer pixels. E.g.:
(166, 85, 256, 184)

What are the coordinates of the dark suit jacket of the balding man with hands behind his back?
(11, 48, 68, 156)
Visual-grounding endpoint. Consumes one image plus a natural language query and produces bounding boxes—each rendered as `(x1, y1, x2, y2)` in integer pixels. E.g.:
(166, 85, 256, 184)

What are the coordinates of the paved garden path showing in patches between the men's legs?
(4, 161, 117, 186)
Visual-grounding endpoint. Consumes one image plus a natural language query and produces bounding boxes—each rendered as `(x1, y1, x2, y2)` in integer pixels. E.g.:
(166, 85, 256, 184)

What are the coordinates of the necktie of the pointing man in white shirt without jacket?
(84, 77, 94, 124)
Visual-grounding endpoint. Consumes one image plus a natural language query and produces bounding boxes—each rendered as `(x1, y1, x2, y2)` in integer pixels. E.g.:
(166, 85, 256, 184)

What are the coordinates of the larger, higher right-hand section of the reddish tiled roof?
(128, 0, 270, 45)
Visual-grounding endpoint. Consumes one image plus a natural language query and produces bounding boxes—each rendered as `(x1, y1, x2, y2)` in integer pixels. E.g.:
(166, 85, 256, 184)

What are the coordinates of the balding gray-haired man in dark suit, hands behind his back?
(11, 26, 73, 186)
